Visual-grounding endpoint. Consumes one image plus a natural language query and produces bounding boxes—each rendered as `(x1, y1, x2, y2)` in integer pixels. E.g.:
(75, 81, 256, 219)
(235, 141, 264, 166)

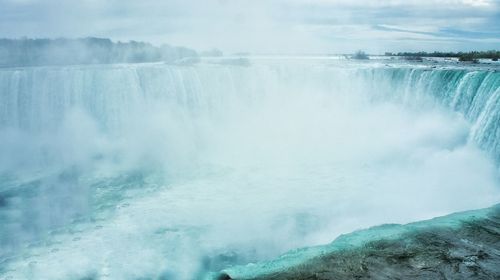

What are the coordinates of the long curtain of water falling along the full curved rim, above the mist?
(0, 60, 500, 162)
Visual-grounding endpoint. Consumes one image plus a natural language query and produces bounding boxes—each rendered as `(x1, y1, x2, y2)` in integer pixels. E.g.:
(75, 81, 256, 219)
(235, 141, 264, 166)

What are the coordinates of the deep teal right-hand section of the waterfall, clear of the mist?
(360, 68, 500, 162)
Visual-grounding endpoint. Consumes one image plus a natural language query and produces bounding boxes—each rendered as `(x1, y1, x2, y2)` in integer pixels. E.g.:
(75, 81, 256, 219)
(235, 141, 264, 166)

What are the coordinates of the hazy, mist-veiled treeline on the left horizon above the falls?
(0, 38, 198, 67)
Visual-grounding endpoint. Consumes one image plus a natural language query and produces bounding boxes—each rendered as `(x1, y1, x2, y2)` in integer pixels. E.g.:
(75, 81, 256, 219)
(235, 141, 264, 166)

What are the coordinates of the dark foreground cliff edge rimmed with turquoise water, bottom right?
(218, 204, 500, 280)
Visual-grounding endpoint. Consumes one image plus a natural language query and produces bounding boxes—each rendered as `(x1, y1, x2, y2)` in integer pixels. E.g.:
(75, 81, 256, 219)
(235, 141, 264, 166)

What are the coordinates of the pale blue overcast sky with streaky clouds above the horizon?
(0, 0, 500, 53)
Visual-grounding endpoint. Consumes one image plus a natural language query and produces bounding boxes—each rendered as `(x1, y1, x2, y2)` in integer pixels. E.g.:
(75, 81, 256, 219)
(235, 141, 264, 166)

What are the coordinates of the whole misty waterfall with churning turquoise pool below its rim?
(0, 59, 500, 279)
